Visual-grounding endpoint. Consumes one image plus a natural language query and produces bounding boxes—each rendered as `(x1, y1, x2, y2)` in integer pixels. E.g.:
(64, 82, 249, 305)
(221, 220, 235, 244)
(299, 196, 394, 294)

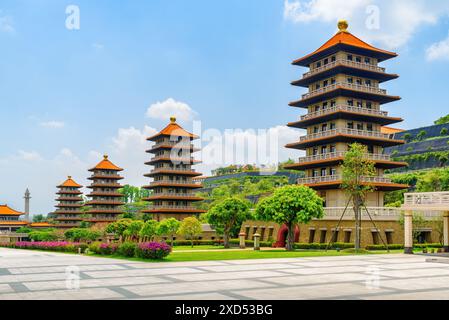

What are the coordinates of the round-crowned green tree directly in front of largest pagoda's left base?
(256, 185, 324, 251)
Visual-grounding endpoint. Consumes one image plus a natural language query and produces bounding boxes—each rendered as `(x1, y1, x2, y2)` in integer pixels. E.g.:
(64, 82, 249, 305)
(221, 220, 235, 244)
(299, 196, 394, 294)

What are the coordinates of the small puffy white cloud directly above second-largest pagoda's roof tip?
(146, 98, 196, 121)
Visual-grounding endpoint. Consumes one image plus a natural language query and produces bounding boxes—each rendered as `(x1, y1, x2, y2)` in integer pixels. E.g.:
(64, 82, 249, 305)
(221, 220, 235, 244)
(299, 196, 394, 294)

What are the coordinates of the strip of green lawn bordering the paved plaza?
(86, 250, 402, 263)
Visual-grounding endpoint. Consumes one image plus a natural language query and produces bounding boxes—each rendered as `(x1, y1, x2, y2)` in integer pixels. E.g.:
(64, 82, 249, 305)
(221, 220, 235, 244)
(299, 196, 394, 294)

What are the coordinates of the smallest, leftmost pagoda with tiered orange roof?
(54, 176, 83, 228)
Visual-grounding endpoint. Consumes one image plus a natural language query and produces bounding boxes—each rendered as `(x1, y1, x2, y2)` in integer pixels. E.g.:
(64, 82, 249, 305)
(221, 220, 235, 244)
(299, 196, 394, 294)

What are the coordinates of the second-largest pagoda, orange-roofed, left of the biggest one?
(143, 117, 205, 221)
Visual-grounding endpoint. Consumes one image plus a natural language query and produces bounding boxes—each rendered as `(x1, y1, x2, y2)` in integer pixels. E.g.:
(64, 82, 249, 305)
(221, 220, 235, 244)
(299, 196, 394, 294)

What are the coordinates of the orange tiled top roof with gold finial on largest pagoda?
(293, 21, 397, 64)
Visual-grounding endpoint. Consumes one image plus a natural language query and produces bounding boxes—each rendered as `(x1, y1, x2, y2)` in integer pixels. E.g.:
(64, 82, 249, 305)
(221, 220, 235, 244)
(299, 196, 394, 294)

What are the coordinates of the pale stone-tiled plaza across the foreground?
(0, 249, 449, 300)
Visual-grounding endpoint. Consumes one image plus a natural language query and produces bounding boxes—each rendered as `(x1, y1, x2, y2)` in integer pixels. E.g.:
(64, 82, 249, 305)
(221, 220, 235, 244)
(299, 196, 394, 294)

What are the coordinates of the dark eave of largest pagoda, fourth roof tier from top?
(287, 111, 404, 129)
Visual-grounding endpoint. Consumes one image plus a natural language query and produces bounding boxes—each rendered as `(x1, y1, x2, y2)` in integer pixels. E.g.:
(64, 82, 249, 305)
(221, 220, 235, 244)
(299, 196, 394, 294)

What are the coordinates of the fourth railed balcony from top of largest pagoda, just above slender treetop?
(286, 128, 405, 149)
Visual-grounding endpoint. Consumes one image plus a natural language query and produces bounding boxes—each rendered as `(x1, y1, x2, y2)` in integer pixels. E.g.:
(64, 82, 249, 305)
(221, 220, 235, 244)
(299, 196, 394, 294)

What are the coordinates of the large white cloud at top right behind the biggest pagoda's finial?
(284, 0, 449, 50)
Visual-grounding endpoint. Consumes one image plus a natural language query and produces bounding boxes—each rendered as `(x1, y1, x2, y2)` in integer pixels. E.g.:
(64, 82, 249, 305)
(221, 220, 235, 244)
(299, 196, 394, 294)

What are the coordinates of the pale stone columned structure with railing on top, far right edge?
(402, 192, 449, 254)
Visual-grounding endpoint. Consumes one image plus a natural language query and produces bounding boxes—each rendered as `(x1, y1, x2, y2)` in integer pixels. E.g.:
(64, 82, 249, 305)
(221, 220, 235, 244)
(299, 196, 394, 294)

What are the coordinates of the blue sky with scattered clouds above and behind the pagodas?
(0, 0, 449, 213)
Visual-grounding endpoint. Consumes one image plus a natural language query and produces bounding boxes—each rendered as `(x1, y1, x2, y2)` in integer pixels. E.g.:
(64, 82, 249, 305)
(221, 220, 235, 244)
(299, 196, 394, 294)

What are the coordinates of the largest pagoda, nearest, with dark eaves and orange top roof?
(286, 20, 408, 208)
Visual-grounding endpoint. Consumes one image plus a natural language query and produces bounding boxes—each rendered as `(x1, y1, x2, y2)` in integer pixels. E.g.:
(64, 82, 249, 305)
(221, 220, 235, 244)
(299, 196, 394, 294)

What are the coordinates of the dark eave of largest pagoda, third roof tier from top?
(289, 87, 401, 108)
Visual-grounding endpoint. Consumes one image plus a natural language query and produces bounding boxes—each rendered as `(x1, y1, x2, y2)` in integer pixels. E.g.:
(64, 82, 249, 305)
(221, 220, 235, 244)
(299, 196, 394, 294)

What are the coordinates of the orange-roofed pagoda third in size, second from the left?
(86, 155, 123, 223)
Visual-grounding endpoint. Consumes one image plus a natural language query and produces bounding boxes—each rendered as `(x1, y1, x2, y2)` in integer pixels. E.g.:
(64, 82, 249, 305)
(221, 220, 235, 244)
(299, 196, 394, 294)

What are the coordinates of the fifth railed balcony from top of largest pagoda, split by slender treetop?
(286, 151, 407, 170)
